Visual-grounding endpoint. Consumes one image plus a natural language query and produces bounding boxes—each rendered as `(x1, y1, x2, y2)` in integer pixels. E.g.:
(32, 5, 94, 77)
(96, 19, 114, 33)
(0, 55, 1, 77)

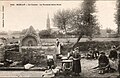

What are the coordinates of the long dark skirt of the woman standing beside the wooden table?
(72, 60, 81, 73)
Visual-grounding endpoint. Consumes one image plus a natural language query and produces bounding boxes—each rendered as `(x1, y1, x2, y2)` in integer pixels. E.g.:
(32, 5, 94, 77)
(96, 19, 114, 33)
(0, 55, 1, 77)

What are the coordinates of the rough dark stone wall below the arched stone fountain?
(5, 46, 47, 67)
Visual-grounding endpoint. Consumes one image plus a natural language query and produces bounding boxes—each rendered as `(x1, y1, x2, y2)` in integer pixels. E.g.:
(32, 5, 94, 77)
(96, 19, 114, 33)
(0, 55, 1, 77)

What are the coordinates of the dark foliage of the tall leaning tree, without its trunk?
(77, 0, 99, 37)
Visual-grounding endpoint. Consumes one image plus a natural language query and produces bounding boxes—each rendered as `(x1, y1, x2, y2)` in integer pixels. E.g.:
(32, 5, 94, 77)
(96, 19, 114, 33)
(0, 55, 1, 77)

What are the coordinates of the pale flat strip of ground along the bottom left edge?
(0, 71, 43, 78)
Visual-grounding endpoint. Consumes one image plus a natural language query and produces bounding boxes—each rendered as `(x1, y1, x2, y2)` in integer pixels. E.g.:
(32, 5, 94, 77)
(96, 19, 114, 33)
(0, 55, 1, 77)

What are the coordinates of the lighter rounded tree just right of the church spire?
(53, 10, 72, 33)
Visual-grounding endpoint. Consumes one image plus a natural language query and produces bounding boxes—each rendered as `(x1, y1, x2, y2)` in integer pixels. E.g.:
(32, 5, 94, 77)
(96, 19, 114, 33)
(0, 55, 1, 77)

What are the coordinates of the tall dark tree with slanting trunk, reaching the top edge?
(72, 0, 100, 47)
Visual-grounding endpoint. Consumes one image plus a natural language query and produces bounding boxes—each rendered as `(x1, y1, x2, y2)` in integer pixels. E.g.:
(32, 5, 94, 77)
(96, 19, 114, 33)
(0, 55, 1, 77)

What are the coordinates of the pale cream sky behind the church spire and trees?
(0, 0, 117, 31)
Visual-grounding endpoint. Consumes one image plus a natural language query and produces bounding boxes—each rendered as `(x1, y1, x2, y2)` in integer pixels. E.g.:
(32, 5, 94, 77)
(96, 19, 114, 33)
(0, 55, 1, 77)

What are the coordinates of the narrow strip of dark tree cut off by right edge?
(115, 0, 120, 35)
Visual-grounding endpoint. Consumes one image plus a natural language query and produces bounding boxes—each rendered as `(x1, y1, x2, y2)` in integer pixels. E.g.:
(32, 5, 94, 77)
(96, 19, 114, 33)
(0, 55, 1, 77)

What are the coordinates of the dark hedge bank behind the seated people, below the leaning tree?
(62, 41, 120, 54)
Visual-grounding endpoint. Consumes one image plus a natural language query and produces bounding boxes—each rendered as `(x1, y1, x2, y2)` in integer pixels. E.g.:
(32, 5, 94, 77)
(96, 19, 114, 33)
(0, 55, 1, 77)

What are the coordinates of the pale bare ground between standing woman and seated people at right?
(81, 59, 118, 78)
